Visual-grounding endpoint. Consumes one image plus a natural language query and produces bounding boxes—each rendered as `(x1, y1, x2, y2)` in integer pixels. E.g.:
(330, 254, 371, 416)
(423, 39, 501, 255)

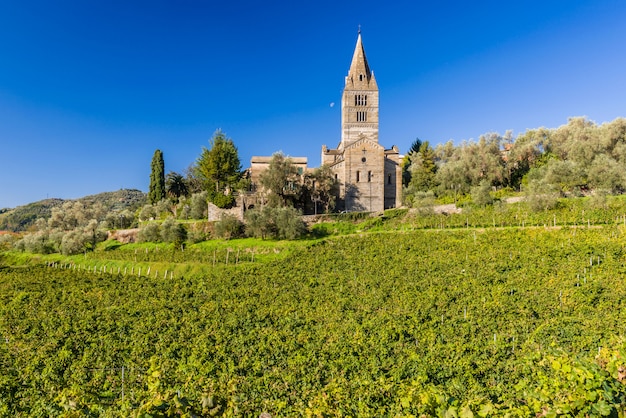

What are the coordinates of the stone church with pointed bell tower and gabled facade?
(322, 31, 402, 211)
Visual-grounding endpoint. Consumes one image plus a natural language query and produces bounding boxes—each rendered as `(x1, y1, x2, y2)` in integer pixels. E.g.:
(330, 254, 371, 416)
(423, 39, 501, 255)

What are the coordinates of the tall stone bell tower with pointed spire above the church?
(339, 29, 378, 149)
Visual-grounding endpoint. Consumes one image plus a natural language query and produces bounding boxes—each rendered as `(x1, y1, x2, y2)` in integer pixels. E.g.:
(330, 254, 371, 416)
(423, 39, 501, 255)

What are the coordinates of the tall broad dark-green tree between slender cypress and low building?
(191, 130, 241, 207)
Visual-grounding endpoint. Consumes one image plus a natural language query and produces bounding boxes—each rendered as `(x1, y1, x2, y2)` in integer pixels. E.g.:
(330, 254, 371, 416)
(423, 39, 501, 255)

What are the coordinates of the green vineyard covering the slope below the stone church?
(0, 222, 626, 417)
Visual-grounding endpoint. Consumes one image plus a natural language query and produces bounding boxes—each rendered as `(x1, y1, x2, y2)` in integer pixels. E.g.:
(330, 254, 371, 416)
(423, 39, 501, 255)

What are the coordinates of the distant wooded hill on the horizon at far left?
(0, 189, 146, 232)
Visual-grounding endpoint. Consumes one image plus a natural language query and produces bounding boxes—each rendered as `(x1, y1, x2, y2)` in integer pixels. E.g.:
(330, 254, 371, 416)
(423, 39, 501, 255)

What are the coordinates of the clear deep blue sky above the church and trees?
(0, 0, 626, 208)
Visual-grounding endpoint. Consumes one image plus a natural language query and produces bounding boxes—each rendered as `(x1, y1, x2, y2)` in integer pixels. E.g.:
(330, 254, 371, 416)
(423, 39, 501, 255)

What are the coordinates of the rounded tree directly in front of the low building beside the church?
(259, 152, 302, 207)
